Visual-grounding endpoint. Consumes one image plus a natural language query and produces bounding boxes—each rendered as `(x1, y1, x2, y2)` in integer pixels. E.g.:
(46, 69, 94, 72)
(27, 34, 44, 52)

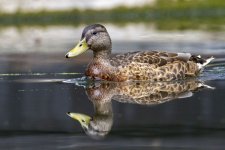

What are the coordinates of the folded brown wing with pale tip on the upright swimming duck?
(110, 51, 192, 66)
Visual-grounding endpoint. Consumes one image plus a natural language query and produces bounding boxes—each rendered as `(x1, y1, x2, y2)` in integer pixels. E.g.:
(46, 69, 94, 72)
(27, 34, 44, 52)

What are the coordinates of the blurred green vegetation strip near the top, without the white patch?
(0, 0, 225, 30)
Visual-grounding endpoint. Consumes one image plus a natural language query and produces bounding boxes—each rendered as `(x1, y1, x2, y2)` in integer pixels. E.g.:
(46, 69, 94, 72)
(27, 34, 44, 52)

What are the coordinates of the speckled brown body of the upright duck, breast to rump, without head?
(86, 51, 211, 81)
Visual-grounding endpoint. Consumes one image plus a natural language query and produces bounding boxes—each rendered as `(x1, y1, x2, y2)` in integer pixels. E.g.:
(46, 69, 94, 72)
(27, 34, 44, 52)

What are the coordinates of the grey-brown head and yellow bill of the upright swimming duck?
(66, 24, 112, 58)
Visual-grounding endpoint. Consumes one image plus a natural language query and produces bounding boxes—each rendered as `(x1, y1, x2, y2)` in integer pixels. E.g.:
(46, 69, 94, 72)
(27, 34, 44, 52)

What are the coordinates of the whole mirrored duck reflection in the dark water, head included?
(68, 79, 212, 138)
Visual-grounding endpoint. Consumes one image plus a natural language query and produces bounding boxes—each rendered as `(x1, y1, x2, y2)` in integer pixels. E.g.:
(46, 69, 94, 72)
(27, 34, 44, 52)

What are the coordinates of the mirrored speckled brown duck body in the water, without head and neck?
(86, 79, 208, 105)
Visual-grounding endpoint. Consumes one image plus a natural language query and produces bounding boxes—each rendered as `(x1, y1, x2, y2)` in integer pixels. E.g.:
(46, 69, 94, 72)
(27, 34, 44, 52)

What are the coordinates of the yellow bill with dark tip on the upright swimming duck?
(66, 38, 89, 58)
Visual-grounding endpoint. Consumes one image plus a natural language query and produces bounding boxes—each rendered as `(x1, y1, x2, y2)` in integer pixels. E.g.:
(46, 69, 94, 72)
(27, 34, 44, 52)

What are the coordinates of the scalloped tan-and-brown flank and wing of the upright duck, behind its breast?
(104, 51, 199, 81)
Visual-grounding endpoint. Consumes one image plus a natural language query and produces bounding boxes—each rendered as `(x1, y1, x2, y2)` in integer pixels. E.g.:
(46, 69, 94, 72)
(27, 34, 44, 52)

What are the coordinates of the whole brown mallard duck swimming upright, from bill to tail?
(66, 24, 214, 82)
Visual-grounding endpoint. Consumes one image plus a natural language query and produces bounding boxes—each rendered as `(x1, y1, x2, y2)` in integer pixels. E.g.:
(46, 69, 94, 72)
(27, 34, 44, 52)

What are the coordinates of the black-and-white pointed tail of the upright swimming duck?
(190, 55, 214, 71)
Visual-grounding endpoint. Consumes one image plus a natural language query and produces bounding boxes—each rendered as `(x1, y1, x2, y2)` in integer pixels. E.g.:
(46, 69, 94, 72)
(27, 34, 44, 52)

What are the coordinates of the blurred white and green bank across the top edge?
(0, 0, 225, 30)
